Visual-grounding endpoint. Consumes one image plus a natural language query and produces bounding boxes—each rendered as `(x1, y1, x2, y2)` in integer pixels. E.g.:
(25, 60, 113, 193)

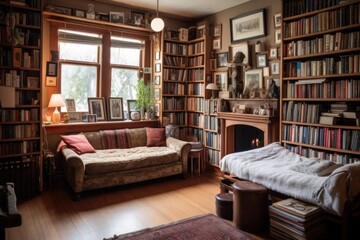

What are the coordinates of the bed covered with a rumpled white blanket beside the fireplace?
(220, 142, 360, 216)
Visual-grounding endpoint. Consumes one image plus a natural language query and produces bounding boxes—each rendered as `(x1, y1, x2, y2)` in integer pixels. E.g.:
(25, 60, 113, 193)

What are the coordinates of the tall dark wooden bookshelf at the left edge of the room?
(0, 0, 41, 199)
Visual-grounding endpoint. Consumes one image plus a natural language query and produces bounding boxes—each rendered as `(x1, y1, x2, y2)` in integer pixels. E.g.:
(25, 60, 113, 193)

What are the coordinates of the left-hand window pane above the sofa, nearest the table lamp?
(59, 30, 102, 111)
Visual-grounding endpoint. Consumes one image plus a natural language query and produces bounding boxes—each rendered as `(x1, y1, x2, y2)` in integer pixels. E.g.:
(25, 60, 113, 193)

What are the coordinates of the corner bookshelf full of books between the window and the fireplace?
(160, 31, 211, 142)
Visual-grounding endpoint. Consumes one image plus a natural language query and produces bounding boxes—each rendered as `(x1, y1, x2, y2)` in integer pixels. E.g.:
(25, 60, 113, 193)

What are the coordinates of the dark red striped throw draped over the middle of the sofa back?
(100, 129, 132, 149)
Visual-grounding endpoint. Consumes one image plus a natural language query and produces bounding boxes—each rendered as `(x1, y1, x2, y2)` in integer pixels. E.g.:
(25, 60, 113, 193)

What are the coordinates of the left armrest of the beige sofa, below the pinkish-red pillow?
(62, 147, 85, 193)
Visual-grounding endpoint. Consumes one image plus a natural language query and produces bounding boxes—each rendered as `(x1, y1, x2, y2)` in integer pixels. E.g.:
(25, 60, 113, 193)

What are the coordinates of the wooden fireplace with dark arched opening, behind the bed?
(218, 112, 279, 157)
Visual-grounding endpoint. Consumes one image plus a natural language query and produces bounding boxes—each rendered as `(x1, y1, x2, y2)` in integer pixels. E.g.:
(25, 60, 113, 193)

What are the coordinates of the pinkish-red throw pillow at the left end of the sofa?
(60, 134, 96, 155)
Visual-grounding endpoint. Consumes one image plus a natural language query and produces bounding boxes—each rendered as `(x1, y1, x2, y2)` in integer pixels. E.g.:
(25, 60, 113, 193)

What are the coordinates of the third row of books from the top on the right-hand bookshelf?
(284, 31, 360, 57)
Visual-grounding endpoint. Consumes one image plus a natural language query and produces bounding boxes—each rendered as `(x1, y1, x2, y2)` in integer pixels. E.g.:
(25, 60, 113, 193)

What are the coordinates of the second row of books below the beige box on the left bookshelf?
(0, 124, 39, 139)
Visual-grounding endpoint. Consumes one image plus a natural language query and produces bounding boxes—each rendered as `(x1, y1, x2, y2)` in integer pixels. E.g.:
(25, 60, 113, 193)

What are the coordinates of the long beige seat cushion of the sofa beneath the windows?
(81, 147, 179, 175)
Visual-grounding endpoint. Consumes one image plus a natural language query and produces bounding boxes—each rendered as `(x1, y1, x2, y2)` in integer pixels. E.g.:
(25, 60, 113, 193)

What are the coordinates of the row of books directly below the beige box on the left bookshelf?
(0, 108, 39, 122)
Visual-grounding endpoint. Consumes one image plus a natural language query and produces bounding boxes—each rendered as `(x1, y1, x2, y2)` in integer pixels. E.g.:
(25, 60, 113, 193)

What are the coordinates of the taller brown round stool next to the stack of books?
(233, 181, 268, 233)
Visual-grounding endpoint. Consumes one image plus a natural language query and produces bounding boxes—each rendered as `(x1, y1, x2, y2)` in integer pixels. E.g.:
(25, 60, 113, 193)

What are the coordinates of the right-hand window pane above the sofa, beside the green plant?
(110, 36, 144, 116)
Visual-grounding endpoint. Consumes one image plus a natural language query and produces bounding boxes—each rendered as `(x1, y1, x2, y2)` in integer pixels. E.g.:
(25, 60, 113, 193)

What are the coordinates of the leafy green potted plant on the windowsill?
(136, 78, 155, 119)
